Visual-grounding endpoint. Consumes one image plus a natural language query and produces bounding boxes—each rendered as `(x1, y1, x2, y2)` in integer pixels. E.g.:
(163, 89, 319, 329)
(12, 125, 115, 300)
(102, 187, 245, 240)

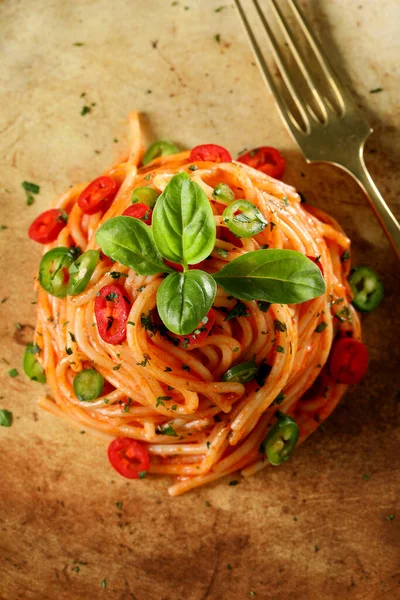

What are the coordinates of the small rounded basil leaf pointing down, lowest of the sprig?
(157, 267, 217, 335)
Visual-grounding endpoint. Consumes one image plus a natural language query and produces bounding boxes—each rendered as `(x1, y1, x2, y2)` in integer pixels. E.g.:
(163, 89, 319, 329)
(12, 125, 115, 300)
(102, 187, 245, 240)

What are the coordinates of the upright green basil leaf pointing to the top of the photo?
(153, 173, 216, 265)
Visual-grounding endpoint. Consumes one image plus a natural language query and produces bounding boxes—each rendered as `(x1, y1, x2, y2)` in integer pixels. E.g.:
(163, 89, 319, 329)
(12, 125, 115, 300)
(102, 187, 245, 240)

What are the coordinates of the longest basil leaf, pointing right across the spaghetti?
(213, 249, 326, 304)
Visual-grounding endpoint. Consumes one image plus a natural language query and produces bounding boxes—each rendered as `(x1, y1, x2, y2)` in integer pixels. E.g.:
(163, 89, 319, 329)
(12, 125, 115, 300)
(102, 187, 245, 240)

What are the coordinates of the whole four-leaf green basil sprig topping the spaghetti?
(96, 173, 325, 335)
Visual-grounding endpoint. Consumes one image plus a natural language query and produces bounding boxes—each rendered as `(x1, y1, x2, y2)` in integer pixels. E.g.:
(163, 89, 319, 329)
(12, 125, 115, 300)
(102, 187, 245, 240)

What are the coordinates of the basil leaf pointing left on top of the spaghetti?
(96, 217, 171, 275)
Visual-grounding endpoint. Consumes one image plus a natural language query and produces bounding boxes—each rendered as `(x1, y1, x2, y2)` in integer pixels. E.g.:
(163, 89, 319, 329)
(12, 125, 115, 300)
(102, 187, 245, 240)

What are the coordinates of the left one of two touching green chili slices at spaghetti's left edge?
(39, 246, 80, 298)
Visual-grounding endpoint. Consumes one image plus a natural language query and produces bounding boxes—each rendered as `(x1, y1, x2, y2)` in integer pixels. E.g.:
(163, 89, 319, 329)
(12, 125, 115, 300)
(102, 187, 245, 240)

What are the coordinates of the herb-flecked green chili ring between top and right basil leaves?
(222, 200, 268, 237)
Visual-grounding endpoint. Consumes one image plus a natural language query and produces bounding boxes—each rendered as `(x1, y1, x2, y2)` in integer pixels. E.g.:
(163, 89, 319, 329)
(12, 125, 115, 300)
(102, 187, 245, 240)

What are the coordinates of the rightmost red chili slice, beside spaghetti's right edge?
(330, 337, 368, 385)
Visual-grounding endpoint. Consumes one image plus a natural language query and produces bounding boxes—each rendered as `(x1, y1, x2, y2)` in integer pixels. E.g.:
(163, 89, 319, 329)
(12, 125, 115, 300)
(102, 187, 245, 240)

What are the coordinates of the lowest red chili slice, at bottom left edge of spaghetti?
(108, 438, 150, 479)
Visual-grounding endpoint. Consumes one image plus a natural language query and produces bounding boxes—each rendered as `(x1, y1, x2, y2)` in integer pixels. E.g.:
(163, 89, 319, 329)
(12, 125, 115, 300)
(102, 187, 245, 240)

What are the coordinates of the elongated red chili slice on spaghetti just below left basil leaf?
(94, 283, 131, 345)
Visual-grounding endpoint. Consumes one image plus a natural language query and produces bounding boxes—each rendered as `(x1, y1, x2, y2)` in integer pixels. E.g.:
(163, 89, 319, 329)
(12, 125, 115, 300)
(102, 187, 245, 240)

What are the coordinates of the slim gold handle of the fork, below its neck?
(345, 155, 400, 259)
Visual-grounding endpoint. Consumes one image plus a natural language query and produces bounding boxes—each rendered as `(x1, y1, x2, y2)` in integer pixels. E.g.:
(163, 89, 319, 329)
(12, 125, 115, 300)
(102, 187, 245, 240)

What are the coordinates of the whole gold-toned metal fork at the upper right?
(235, 0, 400, 258)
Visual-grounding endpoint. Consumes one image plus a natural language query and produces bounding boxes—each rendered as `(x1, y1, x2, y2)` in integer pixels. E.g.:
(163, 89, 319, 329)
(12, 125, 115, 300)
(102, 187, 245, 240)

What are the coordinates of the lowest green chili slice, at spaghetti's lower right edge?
(263, 415, 300, 466)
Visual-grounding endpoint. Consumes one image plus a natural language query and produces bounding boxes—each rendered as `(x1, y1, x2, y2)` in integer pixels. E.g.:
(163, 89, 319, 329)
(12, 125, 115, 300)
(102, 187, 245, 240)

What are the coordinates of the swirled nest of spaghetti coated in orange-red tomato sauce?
(34, 113, 361, 495)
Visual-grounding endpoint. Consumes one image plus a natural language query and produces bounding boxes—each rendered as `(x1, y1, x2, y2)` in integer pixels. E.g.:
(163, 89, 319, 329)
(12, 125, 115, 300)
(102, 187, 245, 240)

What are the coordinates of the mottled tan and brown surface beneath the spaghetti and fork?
(0, 0, 400, 600)
